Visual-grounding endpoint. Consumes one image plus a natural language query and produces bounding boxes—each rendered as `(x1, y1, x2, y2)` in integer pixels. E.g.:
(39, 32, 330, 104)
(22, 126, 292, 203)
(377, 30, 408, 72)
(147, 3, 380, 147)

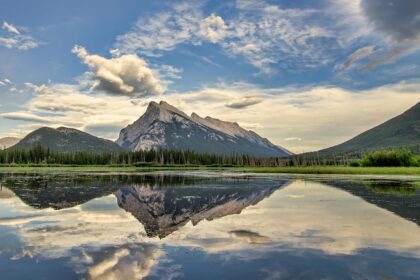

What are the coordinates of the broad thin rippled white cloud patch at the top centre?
(116, 1, 332, 73)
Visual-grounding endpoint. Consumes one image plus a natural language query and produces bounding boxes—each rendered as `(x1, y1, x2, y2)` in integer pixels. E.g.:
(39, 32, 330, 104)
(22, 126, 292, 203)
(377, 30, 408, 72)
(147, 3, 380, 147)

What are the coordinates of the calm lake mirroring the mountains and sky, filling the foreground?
(0, 172, 420, 280)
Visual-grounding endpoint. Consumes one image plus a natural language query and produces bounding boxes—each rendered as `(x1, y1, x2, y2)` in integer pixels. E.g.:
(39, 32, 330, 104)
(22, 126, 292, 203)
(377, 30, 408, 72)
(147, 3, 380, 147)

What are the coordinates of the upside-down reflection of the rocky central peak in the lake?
(115, 179, 288, 238)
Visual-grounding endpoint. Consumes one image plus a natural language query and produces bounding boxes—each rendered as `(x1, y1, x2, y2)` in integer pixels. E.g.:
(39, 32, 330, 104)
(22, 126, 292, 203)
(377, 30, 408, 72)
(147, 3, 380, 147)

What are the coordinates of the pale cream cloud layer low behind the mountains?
(3, 81, 420, 152)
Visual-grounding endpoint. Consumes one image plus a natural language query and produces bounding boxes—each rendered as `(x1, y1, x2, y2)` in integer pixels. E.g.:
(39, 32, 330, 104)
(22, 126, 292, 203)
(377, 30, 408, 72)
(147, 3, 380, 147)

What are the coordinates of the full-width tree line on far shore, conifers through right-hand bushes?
(0, 144, 420, 167)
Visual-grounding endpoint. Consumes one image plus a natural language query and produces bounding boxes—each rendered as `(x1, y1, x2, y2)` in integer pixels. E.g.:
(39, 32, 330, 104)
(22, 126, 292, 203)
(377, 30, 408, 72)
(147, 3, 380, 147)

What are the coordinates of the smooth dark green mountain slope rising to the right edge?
(319, 103, 420, 154)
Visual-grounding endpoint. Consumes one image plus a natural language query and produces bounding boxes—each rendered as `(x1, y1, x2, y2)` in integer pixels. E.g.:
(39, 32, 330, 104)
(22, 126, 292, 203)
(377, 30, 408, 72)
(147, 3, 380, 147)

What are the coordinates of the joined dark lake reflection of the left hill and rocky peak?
(0, 175, 289, 238)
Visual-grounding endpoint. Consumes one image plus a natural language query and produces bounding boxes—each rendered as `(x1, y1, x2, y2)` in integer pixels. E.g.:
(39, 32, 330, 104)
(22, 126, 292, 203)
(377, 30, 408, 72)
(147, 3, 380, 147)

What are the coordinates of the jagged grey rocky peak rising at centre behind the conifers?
(116, 101, 292, 157)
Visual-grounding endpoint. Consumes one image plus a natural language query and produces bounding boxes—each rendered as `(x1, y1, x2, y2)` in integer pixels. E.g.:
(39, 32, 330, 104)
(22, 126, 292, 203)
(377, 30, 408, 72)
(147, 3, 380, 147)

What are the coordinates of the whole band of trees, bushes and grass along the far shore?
(0, 144, 420, 175)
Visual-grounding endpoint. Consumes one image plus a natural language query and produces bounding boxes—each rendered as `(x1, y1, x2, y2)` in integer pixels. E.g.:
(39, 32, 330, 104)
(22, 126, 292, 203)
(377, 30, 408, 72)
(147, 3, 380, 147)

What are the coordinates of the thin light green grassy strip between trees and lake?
(0, 165, 420, 175)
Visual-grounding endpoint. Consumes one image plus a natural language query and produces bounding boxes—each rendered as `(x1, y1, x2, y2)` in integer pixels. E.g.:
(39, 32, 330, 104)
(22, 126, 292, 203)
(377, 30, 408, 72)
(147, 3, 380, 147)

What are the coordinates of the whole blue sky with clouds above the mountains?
(0, 0, 420, 153)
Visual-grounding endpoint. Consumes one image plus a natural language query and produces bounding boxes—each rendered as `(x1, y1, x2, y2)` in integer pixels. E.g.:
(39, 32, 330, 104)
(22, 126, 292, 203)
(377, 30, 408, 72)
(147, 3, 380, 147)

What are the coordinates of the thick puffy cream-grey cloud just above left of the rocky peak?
(72, 46, 164, 96)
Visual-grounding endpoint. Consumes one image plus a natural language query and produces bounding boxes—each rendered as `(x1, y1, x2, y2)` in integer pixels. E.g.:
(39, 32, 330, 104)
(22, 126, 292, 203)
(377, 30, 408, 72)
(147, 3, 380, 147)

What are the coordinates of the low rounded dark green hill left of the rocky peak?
(13, 127, 124, 153)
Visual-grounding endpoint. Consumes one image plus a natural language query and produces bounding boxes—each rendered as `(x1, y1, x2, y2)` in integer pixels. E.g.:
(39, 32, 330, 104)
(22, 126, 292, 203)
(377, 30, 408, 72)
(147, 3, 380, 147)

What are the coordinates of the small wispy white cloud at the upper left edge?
(0, 22, 40, 50)
